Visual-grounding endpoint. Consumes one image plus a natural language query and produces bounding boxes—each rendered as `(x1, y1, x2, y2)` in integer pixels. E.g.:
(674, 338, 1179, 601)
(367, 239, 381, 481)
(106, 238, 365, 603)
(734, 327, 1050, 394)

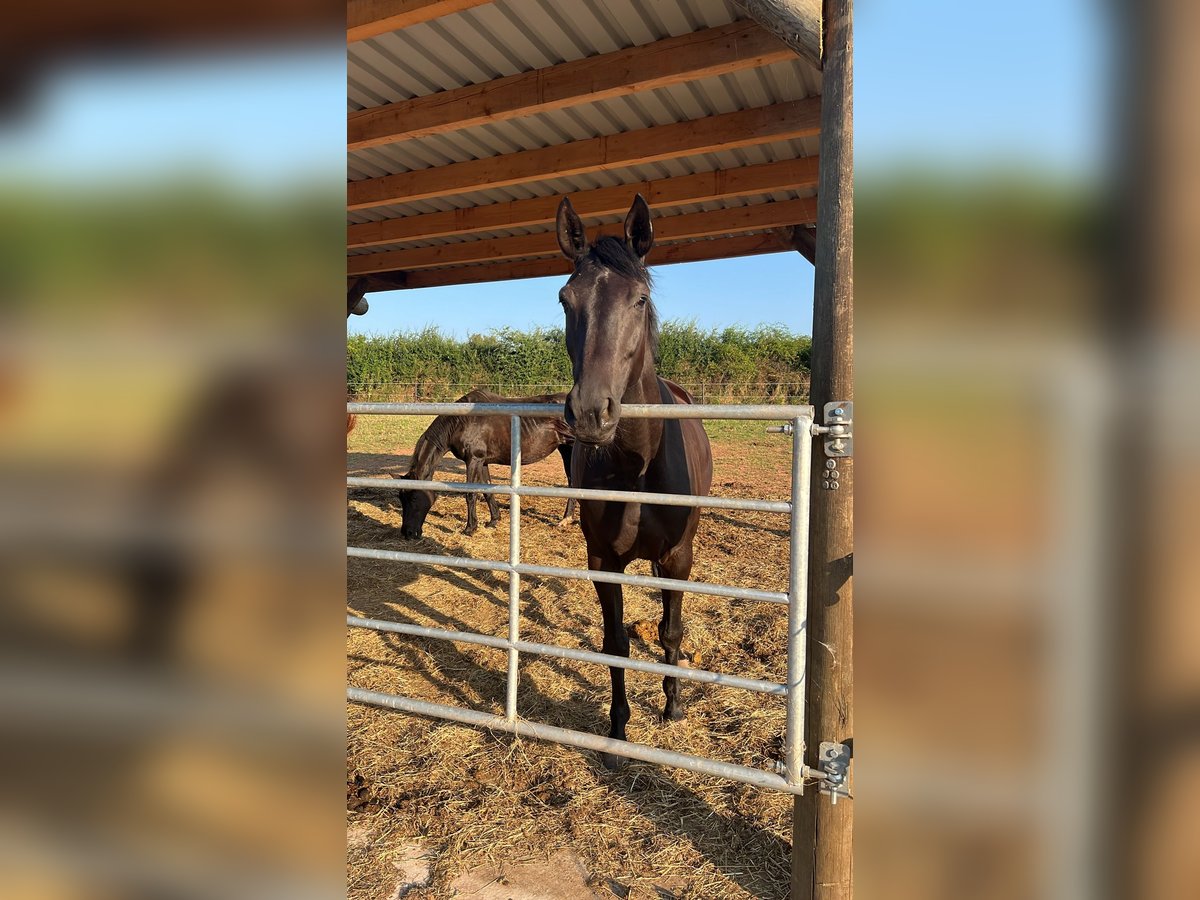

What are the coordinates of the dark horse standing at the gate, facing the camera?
(557, 194, 713, 768)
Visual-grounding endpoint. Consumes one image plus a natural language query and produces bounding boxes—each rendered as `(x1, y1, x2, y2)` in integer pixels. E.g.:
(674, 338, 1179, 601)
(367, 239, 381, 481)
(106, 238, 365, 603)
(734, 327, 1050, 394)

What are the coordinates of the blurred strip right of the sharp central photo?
(854, 0, 1200, 898)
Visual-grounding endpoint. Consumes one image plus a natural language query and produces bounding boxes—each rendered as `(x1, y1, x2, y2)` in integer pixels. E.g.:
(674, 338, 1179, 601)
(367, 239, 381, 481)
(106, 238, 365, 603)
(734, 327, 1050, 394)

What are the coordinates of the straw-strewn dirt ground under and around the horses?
(347, 416, 806, 900)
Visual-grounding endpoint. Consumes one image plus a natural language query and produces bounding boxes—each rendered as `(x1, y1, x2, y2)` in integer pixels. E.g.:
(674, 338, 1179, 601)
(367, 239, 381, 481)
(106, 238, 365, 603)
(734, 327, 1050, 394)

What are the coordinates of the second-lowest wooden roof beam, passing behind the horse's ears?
(347, 197, 817, 275)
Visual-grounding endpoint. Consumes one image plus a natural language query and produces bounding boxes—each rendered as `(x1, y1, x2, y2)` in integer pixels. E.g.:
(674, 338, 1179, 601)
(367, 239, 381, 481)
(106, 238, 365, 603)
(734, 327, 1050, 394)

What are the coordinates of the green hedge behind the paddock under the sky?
(346, 322, 812, 402)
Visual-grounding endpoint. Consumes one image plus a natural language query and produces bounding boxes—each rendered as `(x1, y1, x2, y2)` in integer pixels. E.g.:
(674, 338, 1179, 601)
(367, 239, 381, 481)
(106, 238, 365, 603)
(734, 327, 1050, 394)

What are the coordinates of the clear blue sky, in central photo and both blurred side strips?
(0, 0, 1109, 336)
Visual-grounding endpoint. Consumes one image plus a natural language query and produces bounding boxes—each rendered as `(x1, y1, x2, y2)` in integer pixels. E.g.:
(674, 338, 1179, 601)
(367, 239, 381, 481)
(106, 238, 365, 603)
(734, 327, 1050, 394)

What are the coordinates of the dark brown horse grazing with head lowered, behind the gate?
(398, 390, 575, 539)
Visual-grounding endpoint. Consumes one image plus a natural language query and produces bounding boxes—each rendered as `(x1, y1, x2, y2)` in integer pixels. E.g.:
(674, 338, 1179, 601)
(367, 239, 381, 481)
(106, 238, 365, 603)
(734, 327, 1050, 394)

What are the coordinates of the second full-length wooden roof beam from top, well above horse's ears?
(347, 97, 821, 210)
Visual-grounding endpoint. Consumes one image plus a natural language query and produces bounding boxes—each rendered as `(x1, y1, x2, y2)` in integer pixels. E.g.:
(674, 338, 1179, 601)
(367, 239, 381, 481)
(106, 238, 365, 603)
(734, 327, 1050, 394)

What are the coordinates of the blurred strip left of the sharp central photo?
(0, 0, 346, 898)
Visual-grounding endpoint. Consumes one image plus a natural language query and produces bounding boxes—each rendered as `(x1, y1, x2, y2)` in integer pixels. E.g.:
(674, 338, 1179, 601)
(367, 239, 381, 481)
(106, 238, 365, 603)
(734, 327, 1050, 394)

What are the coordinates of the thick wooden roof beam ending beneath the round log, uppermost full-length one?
(347, 22, 792, 150)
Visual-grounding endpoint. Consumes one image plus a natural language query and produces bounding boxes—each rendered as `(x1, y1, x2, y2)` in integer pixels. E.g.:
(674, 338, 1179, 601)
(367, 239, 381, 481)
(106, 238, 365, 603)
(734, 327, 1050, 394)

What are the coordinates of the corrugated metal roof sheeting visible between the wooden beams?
(348, 0, 820, 285)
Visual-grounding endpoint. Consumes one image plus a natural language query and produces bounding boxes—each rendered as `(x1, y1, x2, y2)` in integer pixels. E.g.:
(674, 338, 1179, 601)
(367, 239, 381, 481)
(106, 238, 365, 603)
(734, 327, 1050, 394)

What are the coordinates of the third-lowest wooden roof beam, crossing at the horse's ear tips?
(347, 156, 817, 247)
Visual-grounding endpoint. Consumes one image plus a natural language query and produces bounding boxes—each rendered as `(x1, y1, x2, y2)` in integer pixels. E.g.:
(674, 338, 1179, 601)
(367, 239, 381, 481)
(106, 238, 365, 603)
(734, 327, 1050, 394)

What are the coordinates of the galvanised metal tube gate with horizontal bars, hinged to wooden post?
(347, 403, 845, 802)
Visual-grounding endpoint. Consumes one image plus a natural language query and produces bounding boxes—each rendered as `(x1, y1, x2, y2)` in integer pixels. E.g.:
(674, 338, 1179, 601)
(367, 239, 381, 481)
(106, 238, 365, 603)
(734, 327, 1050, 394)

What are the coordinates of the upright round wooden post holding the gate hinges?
(792, 0, 854, 900)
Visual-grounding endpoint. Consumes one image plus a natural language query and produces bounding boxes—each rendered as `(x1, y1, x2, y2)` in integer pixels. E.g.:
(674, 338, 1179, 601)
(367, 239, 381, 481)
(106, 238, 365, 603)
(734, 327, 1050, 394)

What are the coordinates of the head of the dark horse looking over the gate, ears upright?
(557, 194, 658, 445)
